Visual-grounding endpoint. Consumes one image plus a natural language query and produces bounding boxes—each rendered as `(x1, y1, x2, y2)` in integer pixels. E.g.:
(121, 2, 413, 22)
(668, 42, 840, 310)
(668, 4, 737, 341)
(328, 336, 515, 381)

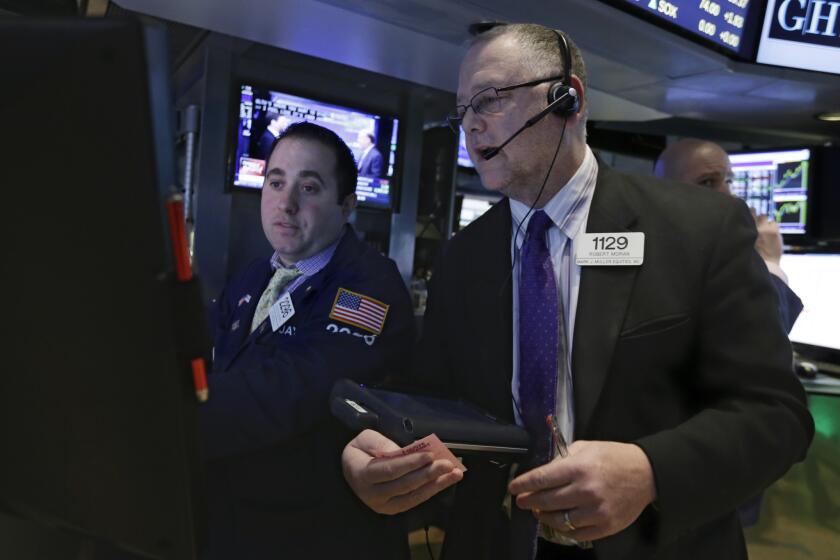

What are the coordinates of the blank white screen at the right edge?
(781, 253, 840, 350)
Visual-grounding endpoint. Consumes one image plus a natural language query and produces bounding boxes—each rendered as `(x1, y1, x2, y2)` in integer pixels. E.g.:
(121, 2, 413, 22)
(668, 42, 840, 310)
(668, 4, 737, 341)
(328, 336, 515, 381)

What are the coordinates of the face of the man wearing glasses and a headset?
(456, 35, 560, 195)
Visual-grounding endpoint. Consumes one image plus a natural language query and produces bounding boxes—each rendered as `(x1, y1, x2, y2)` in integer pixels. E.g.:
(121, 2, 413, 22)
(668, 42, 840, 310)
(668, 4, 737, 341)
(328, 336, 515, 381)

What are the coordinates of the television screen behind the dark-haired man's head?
(233, 84, 399, 208)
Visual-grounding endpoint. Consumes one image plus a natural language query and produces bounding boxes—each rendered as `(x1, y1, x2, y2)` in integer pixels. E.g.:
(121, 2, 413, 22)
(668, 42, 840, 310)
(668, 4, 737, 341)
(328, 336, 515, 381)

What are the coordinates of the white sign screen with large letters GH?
(756, 0, 840, 74)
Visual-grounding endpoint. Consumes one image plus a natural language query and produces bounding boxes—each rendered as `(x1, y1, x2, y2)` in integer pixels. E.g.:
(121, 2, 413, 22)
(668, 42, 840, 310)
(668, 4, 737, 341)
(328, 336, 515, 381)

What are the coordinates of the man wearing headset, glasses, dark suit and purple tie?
(342, 25, 813, 560)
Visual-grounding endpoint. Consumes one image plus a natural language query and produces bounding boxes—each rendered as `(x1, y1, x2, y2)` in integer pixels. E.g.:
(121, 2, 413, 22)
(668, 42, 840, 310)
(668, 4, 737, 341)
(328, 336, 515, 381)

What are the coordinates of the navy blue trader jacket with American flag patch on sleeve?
(201, 228, 414, 559)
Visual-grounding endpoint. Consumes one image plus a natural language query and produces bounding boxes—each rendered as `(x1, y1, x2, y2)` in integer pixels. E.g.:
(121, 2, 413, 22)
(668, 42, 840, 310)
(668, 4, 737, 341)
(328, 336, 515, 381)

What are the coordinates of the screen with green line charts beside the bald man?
(729, 149, 811, 235)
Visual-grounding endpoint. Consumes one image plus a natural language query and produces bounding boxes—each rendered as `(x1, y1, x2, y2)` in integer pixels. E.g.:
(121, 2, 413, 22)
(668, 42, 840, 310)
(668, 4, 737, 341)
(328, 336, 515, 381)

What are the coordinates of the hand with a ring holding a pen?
(508, 441, 656, 541)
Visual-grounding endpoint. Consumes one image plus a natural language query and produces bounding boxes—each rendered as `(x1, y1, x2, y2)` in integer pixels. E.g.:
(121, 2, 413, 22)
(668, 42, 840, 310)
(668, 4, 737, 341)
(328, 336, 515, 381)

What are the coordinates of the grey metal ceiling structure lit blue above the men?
(118, 0, 840, 144)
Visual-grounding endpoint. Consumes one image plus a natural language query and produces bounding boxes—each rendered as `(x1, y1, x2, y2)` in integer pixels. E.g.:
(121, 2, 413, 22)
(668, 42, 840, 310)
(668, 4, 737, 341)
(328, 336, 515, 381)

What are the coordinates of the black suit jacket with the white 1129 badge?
(418, 165, 813, 560)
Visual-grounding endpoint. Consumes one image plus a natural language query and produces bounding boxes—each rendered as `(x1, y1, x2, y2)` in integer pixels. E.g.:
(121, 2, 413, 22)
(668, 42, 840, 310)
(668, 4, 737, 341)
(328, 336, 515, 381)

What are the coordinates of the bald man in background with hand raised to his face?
(654, 138, 802, 333)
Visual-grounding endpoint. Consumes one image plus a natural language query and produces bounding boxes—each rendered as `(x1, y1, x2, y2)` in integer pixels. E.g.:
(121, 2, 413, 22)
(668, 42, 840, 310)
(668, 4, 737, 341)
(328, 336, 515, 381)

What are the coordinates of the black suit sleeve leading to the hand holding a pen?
(636, 200, 814, 542)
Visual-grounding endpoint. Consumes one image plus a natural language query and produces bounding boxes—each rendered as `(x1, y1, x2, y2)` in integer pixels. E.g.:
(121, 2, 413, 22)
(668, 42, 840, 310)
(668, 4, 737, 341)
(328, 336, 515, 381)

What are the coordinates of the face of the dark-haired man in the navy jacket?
(261, 138, 355, 265)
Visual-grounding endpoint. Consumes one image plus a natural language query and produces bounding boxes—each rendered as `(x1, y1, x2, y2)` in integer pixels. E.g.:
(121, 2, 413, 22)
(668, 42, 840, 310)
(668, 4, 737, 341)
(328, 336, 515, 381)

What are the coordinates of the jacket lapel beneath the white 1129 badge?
(572, 163, 639, 438)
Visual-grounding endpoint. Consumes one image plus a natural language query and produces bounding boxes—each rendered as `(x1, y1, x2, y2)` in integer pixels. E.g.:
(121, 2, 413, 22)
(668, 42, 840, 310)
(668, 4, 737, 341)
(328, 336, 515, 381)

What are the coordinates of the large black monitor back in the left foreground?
(0, 18, 209, 560)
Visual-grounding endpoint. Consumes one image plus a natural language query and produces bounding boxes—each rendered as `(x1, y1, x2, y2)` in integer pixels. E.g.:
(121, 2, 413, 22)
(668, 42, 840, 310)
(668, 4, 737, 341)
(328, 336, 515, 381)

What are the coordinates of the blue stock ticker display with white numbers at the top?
(608, 0, 760, 58)
